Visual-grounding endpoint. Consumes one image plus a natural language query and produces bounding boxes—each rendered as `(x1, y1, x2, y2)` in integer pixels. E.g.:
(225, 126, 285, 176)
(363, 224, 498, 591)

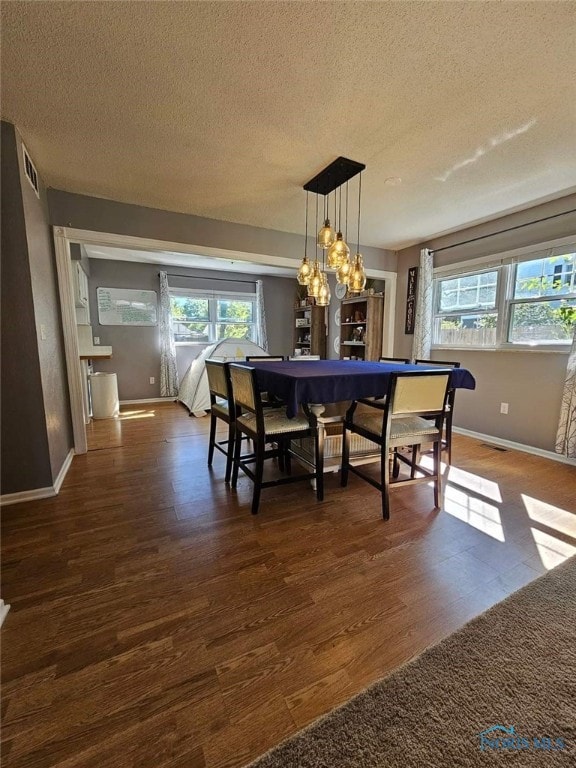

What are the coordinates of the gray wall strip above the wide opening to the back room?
(48, 189, 396, 272)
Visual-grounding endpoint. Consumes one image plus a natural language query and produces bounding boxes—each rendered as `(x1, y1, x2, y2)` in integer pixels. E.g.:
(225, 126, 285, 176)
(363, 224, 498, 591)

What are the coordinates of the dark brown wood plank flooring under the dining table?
(1, 404, 576, 768)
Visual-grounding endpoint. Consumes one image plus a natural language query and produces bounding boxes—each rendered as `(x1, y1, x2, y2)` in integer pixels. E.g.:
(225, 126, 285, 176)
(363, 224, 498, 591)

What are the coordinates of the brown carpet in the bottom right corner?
(251, 557, 576, 768)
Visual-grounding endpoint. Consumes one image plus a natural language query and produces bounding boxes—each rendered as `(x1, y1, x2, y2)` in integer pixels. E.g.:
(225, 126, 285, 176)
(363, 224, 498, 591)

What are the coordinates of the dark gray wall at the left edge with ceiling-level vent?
(1, 122, 72, 494)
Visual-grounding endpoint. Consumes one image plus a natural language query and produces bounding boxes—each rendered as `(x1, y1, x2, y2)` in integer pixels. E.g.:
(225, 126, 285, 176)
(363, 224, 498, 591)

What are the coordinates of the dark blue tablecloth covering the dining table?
(247, 360, 476, 418)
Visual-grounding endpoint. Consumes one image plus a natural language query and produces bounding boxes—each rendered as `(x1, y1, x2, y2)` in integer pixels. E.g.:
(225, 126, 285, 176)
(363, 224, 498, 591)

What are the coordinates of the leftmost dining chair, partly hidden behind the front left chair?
(205, 360, 238, 483)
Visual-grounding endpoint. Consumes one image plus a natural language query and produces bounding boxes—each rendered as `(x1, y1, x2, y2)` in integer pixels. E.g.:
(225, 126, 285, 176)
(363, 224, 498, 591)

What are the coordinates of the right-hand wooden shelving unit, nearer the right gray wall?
(340, 296, 384, 360)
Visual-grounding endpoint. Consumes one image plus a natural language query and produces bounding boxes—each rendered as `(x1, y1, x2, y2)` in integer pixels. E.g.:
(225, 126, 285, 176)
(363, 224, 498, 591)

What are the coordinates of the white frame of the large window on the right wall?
(432, 237, 576, 352)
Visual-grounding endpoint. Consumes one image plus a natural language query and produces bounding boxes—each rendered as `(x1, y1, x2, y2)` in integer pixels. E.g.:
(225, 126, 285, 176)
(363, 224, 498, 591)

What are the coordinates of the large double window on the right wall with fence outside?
(434, 244, 576, 348)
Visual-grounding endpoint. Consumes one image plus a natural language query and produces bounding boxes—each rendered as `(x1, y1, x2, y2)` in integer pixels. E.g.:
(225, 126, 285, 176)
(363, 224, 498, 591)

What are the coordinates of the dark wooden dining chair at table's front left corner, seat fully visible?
(230, 363, 324, 515)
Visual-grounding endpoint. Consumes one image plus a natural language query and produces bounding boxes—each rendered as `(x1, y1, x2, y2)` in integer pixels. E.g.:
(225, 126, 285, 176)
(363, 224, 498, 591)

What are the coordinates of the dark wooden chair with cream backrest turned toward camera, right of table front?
(340, 371, 450, 520)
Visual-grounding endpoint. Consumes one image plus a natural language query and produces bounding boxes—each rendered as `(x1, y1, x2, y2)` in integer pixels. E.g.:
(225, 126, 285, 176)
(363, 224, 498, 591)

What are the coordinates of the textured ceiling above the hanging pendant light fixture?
(1, 0, 576, 248)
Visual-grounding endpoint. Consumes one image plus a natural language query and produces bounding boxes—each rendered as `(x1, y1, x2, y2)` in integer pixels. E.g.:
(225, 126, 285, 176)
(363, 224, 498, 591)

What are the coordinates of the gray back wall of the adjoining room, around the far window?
(89, 259, 295, 400)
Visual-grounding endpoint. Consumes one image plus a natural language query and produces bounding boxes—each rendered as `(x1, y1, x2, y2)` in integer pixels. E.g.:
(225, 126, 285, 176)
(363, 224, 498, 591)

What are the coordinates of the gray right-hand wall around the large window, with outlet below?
(394, 195, 576, 451)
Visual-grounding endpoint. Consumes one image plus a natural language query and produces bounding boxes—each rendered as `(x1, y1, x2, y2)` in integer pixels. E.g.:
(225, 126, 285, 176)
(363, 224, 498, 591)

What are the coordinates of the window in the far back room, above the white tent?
(170, 289, 256, 344)
